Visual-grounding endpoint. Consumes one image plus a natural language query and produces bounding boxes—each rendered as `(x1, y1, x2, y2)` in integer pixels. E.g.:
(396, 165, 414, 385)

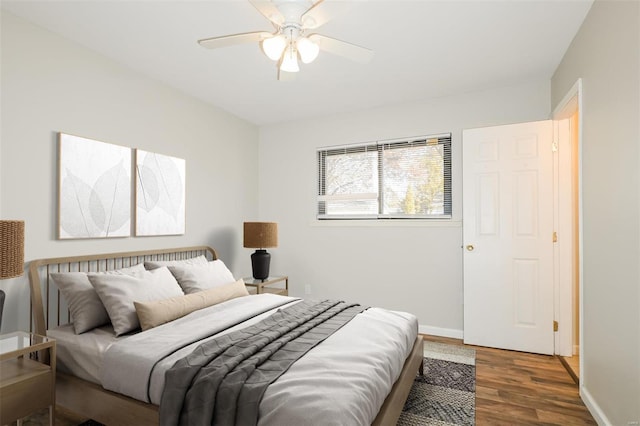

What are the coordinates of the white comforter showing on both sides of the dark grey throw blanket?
(101, 294, 418, 426)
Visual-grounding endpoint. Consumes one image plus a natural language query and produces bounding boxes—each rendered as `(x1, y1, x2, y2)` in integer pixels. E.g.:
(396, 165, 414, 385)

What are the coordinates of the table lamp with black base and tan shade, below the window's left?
(244, 222, 278, 281)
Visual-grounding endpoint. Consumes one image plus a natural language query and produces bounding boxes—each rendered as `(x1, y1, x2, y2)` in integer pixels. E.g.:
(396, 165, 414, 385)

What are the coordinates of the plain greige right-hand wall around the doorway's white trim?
(551, 0, 640, 425)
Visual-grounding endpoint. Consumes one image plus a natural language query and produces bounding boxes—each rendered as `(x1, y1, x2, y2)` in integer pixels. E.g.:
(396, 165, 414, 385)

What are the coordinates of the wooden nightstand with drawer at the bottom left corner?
(0, 331, 56, 425)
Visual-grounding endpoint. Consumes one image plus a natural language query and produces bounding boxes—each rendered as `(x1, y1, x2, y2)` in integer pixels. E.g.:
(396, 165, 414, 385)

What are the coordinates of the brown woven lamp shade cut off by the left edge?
(0, 220, 24, 279)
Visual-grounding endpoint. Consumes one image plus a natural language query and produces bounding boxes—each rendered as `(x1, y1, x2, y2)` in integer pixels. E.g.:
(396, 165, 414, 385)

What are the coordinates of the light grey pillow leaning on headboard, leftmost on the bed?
(49, 263, 145, 334)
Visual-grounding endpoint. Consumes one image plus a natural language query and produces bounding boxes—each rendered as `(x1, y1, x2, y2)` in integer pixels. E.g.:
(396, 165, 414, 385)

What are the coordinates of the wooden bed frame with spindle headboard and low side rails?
(29, 246, 423, 426)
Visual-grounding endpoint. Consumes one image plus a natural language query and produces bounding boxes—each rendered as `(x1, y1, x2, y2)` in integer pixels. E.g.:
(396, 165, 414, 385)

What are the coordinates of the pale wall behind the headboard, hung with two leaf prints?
(0, 12, 258, 332)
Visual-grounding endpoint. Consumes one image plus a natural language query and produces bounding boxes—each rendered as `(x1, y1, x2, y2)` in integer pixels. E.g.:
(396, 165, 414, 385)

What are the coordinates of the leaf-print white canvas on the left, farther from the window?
(58, 133, 131, 239)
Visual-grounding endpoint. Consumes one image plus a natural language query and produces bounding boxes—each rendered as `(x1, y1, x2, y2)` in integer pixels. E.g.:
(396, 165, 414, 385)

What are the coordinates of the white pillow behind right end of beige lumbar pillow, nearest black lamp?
(169, 259, 235, 294)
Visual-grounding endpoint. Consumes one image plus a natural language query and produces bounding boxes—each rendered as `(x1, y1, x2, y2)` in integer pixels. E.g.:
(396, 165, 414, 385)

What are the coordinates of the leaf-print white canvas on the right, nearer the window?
(136, 149, 186, 236)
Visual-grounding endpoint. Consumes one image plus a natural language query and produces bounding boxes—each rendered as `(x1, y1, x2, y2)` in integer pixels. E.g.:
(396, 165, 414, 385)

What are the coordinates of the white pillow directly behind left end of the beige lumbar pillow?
(89, 266, 184, 336)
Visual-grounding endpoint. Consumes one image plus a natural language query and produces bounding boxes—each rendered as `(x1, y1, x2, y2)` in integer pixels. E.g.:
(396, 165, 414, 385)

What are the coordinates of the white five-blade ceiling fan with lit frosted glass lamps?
(198, 0, 373, 80)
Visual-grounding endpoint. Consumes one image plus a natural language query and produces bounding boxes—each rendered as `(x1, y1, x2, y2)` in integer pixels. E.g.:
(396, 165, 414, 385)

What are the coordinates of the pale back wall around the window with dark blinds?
(260, 81, 550, 337)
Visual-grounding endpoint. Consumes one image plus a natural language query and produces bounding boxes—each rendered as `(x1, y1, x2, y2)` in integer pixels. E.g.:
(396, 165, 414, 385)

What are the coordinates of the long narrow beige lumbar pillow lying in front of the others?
(133, 279, 249, 331)
